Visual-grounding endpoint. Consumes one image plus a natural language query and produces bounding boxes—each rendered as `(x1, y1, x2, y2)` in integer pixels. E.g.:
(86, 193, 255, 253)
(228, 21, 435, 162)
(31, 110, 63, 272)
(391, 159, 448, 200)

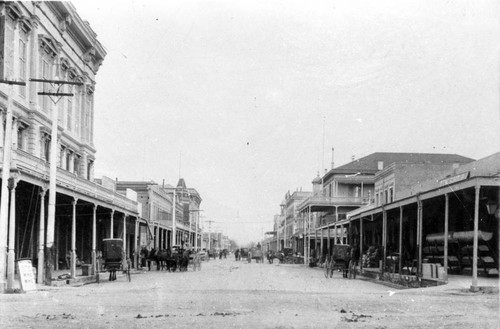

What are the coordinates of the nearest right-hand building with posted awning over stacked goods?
(348, 153, 500, 289)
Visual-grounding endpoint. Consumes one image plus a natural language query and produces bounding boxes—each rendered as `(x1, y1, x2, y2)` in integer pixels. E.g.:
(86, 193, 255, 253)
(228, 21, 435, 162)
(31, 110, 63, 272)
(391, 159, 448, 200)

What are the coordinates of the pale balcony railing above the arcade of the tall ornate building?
(13, 150, 137, 214)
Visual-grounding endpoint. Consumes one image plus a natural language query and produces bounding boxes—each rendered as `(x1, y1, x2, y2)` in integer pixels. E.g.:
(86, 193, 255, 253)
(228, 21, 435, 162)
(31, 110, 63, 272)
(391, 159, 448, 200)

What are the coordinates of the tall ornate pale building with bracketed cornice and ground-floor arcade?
(0, 1, 138, 290)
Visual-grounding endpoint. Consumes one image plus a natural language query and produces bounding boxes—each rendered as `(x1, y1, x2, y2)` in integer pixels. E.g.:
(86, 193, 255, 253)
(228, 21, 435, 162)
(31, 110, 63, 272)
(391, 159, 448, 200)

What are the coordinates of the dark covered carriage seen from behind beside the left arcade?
(102, 239, 131, 282)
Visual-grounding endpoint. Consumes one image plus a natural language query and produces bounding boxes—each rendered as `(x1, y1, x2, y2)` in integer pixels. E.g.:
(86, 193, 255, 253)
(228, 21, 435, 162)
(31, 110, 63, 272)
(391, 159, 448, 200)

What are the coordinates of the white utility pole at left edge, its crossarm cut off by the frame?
(0, 80, 26, 293)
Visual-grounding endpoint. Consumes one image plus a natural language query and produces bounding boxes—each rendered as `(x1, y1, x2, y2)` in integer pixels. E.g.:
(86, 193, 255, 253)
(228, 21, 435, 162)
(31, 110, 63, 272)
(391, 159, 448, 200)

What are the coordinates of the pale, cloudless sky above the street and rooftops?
(73, 0, 500, 244)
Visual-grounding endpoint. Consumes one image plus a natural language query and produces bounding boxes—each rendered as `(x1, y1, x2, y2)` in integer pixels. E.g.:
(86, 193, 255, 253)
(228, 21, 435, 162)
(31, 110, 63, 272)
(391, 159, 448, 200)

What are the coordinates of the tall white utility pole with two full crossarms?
(30, 77, 83, 284)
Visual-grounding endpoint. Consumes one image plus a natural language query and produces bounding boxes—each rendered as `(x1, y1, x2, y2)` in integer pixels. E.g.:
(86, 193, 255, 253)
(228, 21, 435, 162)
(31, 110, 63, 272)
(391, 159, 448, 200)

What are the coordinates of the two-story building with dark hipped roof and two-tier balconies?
(299, 152, 473, 257)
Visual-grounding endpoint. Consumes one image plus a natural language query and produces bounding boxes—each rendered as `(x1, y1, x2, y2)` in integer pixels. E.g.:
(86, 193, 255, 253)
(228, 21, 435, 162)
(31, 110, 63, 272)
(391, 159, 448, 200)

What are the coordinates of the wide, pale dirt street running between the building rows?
(0, 258, 499, 328)
